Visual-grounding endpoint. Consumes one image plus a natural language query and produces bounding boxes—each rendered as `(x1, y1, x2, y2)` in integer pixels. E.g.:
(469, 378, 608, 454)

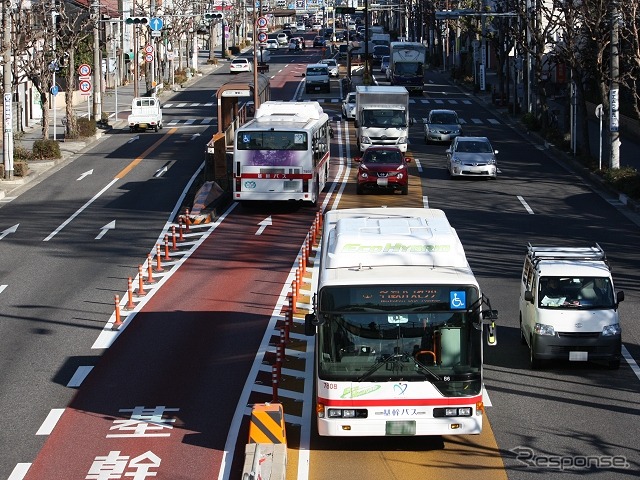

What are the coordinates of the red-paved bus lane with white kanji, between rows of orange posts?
(25, 208, 315, 480)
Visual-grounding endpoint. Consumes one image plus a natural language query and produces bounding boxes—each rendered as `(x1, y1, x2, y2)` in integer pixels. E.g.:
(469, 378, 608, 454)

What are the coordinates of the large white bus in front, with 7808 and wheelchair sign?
(305, 208, 497, 436)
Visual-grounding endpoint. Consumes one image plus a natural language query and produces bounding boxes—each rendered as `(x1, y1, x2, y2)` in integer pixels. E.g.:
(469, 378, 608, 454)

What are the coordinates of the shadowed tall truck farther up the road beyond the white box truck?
(389, 42, 427, 94)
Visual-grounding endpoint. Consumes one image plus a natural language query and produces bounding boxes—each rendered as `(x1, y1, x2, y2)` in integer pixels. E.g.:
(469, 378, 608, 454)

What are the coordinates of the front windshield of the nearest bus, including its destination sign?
(318, 285, 482, 396)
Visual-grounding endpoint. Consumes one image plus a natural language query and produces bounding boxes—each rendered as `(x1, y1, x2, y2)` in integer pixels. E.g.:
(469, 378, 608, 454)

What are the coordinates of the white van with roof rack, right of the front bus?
(520, 244, 624, 369)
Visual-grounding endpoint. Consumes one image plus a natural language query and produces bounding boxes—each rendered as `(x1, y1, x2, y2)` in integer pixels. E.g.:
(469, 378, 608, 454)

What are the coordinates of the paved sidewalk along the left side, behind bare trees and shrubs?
(0, 50, 230, 200)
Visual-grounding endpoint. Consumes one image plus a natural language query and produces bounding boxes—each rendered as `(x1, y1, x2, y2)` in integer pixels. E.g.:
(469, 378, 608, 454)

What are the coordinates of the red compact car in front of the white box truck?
(353, 146, 411, 195)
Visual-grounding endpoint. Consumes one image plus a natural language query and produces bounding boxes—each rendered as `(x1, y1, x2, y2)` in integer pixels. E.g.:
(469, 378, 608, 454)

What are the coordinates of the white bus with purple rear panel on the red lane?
(233, 101, 330, 204)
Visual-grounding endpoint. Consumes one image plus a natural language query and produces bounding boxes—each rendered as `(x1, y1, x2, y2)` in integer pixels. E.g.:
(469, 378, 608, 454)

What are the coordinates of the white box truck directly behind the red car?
(354, 85, 411, 152)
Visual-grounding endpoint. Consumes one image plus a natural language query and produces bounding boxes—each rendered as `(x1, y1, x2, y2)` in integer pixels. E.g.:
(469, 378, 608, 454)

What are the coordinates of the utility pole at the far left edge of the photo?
(2, 0, 13, 180)
